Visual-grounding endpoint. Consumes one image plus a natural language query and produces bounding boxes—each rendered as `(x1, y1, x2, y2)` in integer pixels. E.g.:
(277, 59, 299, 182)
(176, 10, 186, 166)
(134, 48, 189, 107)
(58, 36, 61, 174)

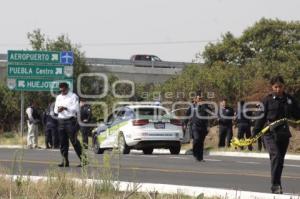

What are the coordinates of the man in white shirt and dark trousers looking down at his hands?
(54, 82, 86, 167)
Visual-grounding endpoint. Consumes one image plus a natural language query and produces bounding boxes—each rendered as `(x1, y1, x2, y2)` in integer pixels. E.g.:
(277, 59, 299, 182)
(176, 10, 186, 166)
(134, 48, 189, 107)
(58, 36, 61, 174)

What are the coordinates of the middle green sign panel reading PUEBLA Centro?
(7, 64, 73, 79)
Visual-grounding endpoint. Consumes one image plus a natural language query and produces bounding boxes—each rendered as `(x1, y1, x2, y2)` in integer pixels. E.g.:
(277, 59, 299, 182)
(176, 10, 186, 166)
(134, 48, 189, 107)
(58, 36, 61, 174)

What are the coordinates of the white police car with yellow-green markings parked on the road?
(93, 105, 183, 154)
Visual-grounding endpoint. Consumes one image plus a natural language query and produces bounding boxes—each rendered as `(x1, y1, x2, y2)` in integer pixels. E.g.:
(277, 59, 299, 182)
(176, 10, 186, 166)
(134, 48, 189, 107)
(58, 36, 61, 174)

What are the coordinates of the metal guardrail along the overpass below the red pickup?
(0, 54, 191, 69)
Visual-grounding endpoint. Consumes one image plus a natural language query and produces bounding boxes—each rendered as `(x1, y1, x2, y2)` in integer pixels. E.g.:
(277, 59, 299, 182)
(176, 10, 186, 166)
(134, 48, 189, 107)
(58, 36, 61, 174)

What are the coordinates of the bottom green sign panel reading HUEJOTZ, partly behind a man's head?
(7, 78, 73, 91)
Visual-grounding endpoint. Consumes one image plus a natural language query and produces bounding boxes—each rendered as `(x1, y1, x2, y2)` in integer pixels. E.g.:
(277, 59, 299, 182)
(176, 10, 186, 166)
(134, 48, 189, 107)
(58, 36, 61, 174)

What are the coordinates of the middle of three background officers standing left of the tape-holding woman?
(236, 101, 253, 151)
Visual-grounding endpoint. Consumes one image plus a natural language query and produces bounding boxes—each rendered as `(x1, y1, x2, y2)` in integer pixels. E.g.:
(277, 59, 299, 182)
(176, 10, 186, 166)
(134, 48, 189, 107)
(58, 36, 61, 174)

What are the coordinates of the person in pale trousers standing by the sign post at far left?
(26, 101, 39, 149)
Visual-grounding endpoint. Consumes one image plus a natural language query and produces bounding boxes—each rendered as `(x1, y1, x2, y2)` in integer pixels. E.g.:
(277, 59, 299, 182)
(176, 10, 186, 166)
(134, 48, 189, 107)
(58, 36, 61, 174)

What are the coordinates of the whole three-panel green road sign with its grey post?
(7, 50, 74, 137)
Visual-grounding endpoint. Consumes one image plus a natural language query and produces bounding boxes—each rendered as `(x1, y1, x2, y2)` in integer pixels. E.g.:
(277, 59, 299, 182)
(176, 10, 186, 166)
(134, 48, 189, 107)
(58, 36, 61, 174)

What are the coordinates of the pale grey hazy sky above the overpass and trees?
(0, 0, 300, 62)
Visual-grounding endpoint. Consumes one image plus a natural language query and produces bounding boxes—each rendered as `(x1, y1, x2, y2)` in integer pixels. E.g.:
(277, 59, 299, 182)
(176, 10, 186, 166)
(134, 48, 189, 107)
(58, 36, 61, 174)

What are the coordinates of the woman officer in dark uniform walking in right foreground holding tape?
(253, 76, 300, 194)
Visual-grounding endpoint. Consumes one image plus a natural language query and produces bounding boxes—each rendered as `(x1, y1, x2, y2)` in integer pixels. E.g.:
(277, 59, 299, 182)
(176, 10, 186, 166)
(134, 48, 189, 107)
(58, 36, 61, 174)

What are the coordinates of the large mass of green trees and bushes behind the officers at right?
(151, 18, 300, 103)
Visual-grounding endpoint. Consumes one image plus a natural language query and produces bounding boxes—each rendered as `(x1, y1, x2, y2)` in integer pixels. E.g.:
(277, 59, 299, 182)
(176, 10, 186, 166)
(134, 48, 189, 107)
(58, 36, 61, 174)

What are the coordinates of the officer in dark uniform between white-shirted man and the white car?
(80, 99, 92, 149)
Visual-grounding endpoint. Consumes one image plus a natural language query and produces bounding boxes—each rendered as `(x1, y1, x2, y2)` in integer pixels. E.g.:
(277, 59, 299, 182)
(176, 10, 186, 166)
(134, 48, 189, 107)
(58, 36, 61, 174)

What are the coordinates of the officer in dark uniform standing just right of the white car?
(187, 95, 209, 162)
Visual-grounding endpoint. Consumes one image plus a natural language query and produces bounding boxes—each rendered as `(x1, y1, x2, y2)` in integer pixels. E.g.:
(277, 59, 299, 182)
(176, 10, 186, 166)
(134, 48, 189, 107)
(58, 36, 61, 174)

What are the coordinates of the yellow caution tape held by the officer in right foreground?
(230, 118, 300, 148)
